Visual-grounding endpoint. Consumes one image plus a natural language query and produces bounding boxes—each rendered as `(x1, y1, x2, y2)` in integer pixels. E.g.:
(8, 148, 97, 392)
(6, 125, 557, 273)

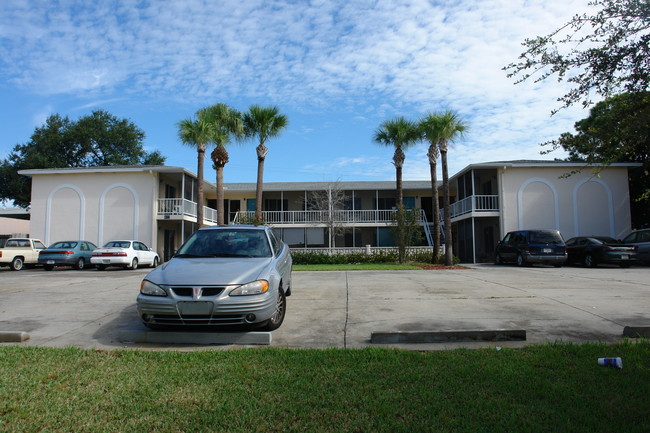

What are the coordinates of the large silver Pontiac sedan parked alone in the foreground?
(137, 225, 292, 331)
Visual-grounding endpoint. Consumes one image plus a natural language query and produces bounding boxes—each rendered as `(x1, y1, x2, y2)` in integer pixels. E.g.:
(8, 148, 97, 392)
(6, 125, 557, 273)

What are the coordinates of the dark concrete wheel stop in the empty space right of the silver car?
(370, 329, 526, 344)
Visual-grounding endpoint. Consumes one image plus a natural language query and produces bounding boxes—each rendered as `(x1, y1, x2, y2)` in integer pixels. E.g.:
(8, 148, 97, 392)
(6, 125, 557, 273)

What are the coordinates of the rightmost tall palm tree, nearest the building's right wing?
(437, 110, 467, 266)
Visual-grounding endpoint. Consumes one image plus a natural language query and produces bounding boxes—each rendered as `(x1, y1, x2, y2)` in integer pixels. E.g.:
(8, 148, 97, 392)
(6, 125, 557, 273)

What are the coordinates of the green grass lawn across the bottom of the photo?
(0, 342, 650, 433)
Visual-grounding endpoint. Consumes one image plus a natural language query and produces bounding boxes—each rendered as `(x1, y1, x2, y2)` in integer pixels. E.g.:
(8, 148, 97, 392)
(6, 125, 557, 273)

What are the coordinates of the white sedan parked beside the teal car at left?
(90, 240, 160, 271)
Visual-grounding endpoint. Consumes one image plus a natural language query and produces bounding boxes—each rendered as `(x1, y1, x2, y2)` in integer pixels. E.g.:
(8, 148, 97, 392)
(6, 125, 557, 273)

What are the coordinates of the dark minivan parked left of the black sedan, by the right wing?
(494, 230, 567, 268)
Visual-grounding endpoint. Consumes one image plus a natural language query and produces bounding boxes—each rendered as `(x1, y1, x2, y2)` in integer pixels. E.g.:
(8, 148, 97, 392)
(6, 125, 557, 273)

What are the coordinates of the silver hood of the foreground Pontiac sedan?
(145, 257, 272, 285)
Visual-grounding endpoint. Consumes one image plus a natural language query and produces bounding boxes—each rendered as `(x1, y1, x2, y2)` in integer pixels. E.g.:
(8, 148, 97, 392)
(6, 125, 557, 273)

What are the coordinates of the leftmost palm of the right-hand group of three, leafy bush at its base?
(373, 117, 420, 210)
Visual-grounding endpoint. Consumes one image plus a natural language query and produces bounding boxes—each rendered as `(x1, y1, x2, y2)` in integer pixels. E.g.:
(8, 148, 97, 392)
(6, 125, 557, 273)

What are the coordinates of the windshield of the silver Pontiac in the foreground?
(176, 229, 271, 257)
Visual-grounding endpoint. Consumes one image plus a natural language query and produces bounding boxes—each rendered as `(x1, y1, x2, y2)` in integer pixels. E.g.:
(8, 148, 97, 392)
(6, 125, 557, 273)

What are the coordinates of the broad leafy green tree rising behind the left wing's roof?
(0, 110, 165, 208)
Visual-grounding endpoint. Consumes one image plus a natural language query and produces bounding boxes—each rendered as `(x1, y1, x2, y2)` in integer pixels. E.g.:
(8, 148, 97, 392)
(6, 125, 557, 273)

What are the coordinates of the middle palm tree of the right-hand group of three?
(418, 113, 441, 264)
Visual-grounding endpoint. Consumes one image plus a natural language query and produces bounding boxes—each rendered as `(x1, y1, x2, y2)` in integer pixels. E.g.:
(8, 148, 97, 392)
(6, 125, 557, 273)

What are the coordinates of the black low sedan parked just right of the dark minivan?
(566, 236, 637, 268)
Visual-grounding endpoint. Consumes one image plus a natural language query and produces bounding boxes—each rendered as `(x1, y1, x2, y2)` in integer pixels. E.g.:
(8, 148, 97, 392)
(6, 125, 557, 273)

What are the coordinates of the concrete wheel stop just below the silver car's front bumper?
(118, 330, 271, 345)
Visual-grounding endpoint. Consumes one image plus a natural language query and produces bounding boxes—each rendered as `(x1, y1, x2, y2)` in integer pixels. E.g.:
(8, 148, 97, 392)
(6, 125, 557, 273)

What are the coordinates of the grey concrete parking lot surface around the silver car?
(0, 265, 650, 350)
